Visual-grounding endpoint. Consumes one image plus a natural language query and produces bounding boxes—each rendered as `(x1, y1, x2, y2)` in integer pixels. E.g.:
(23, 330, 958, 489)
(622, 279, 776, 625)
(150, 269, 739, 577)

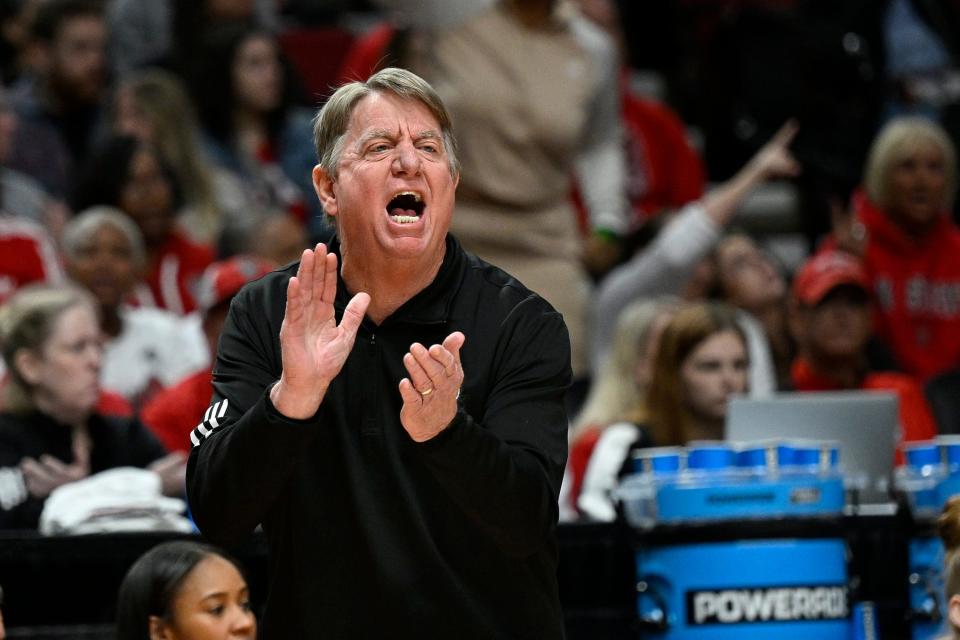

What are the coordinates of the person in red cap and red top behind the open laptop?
(789, 251, 937, 463)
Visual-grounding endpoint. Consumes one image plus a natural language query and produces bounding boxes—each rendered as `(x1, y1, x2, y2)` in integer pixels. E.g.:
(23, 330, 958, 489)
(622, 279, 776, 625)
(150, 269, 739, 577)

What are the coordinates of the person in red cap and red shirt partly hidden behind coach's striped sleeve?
(140, 256, 273, 453)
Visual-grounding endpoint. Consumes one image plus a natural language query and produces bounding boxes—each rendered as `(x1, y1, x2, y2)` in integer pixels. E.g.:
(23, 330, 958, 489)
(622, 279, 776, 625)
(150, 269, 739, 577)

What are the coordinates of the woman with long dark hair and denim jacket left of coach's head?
(190, 27, 325, 241)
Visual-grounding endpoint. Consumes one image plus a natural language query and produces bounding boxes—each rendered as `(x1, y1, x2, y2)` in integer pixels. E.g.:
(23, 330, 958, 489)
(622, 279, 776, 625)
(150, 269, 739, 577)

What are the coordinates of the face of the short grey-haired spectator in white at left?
(66, 224, 139, 309)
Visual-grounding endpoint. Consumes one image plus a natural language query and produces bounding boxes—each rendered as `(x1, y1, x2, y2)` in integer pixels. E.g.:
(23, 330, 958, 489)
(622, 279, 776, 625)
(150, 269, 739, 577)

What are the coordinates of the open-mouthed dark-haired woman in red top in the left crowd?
(73, 136, 213, 315)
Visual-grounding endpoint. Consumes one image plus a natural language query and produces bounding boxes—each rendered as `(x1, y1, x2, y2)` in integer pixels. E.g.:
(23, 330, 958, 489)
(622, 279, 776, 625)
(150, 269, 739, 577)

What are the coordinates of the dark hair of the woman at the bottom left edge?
(116, 540, 242, 640)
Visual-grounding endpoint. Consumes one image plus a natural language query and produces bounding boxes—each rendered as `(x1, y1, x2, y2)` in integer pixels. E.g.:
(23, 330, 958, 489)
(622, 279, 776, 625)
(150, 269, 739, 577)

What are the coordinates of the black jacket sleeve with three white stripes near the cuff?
(187, 290, 315, 545)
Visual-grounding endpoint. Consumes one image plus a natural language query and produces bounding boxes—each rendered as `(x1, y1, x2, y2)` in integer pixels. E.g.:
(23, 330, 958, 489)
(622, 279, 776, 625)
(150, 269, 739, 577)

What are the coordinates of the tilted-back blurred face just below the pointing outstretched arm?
(716, 236, 787, 311)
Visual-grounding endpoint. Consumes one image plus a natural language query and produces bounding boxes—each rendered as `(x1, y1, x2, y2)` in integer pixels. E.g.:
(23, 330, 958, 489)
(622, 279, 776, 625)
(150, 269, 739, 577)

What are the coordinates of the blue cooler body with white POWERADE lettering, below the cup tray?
(637, 520, 851, 640)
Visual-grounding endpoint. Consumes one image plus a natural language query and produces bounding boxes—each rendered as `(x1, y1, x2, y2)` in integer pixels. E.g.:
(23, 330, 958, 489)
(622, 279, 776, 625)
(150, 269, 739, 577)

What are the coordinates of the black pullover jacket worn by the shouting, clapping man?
(187, 236, 571, 640)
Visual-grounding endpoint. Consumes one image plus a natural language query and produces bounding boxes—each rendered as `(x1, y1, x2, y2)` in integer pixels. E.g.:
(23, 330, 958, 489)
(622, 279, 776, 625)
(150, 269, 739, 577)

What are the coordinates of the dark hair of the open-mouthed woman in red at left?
(70, 136, 183, 211)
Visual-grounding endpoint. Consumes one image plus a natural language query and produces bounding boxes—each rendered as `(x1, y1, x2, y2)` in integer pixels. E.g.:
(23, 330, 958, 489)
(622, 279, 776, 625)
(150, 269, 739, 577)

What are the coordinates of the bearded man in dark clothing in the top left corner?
(10, 0, 107, 198)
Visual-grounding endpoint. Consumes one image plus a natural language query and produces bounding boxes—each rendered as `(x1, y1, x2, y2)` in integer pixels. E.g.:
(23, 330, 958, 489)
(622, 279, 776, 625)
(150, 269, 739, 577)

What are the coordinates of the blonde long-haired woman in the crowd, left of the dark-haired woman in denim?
(112, 69, 255, 256)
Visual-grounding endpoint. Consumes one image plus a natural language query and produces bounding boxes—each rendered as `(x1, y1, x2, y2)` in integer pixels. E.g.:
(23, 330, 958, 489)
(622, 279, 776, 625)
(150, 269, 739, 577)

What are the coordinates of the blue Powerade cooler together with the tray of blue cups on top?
(617, 442, 860, 640)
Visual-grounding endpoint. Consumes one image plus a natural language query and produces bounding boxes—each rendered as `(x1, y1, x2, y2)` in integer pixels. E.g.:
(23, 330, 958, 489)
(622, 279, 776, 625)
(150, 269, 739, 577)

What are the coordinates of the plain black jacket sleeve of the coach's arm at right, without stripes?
(419, 297, 571, 557)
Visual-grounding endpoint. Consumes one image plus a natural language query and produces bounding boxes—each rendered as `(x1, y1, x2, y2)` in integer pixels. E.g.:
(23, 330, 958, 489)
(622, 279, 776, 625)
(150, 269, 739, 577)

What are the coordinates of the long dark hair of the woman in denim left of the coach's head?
(189, 24, 300, 145)
